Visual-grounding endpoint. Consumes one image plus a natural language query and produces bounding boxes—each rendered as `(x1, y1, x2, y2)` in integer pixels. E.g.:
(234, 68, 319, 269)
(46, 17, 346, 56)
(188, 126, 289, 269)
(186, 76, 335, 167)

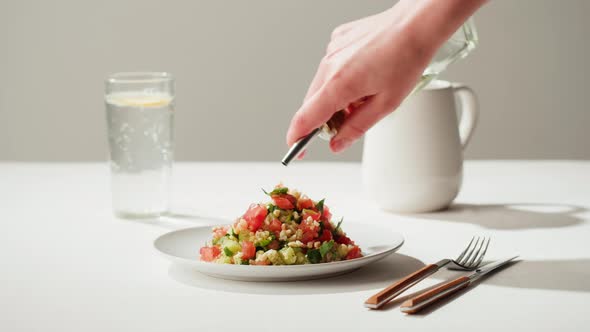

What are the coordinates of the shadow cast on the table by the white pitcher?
(412, 203, 587, 229)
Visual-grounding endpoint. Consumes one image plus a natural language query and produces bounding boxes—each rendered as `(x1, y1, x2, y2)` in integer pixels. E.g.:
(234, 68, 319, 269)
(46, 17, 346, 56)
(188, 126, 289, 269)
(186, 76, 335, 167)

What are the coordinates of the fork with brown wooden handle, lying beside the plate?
(365, 236, 490, 309)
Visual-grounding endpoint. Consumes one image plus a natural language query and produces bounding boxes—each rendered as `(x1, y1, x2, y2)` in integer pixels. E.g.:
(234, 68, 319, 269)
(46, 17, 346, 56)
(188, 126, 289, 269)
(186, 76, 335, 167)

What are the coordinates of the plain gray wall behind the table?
(0, 0, 590, 161)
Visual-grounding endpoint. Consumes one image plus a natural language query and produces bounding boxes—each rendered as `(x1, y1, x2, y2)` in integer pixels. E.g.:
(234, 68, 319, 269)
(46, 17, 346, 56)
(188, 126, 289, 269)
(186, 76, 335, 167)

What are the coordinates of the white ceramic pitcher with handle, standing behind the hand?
(362, 80, 478, 213)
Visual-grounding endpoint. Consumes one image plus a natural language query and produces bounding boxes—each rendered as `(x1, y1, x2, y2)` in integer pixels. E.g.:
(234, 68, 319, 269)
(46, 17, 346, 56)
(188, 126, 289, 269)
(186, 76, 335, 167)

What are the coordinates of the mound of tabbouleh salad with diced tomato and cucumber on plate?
(200, 184, 362, 265)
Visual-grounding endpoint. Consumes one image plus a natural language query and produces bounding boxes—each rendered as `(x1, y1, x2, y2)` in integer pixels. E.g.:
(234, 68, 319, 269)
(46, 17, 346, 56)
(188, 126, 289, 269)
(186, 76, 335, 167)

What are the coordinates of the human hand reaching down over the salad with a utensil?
(287, 0, 485, 157)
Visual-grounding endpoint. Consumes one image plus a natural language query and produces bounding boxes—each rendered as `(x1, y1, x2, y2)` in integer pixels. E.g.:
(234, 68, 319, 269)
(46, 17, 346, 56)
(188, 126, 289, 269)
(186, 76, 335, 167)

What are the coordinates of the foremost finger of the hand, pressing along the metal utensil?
(287, 74, 361, 146)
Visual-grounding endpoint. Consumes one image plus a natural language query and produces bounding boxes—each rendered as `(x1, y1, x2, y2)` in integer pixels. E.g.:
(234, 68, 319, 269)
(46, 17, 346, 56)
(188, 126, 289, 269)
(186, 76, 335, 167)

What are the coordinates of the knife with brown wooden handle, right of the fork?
(400, 256, 518, 314)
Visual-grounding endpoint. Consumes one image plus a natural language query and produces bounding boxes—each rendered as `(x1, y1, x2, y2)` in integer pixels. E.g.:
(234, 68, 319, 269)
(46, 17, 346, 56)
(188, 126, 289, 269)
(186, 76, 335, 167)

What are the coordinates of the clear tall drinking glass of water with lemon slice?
(105, 72, 174, 218)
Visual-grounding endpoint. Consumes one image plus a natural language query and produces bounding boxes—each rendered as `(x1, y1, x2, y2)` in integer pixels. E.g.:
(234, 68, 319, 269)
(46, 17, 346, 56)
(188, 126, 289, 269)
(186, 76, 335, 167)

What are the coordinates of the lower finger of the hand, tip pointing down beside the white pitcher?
(330, 94, 394, 153)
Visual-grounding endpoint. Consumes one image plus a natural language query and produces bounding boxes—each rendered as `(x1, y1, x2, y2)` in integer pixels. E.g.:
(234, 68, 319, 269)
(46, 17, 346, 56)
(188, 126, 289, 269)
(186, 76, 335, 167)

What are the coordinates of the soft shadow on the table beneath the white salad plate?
(168, 253, 424, 294)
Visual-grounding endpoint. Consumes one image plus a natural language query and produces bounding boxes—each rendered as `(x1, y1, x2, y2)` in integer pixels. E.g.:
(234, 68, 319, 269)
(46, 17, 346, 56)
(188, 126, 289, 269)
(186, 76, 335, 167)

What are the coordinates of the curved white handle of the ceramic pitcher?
(453, 83, 479, 149)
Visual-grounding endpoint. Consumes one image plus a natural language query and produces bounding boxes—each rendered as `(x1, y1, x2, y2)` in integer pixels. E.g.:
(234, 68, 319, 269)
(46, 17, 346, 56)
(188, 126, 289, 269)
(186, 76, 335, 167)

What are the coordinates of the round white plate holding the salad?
(154, 222, 404, 281)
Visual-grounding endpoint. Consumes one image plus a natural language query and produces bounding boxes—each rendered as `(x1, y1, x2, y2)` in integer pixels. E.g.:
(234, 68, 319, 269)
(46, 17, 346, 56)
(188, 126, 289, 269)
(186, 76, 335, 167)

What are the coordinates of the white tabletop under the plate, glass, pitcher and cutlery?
(0, 161, 590, 332)
